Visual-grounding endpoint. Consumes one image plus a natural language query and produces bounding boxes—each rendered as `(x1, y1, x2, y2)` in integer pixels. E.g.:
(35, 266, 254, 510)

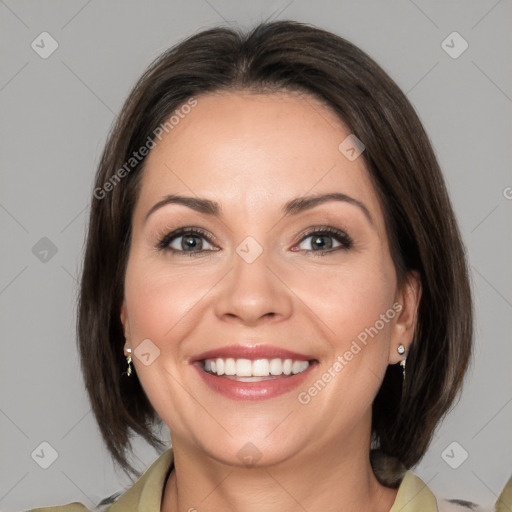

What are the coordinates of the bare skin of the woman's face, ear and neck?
(121, 91, 421, 512)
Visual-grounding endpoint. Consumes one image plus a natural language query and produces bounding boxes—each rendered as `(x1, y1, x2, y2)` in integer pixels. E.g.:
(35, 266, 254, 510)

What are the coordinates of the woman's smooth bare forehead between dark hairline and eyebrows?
(132, 91, 380, 228)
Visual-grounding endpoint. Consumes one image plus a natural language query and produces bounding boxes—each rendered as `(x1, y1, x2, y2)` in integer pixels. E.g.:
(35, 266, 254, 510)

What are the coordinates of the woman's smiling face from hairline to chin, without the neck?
(121, 92, 417, 465)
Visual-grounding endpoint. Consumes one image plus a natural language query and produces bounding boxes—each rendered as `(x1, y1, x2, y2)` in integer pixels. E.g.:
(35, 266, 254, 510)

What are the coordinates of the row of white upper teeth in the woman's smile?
(204, 357, 309, 377)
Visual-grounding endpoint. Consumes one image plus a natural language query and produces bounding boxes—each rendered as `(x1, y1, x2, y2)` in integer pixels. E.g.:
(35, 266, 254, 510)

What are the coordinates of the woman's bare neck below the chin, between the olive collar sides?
(161, 428, 397, 512)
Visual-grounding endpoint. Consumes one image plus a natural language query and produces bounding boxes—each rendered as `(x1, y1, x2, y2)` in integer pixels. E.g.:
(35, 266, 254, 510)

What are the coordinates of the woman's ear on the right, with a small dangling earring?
(389, 270, 421, 364)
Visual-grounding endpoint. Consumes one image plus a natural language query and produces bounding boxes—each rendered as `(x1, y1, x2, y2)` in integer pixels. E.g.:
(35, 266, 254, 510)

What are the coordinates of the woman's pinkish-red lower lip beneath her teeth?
(194, 361, 317, 400)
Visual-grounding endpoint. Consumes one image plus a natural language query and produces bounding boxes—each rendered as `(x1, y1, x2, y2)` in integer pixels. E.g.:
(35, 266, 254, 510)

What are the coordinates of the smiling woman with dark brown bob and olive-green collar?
(30, 22, 472, 512)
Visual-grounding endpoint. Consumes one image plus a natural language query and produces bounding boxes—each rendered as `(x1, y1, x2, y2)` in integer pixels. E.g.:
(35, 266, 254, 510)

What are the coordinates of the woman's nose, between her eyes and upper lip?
(215, 245, 293, 327)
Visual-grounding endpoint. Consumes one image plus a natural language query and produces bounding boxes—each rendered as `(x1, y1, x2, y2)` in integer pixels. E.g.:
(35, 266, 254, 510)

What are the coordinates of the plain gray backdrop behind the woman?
(0, 0, 512, 511)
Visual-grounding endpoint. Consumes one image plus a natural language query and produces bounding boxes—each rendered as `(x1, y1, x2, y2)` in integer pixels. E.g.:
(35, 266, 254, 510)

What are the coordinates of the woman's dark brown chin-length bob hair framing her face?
(77, 21, 473, 483)
